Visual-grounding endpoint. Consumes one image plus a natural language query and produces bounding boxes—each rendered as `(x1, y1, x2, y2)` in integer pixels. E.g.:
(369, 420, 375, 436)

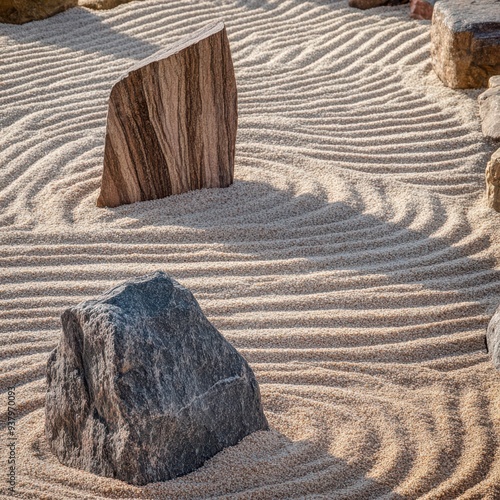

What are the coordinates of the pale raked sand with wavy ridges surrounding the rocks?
(0, 0, 500, 499)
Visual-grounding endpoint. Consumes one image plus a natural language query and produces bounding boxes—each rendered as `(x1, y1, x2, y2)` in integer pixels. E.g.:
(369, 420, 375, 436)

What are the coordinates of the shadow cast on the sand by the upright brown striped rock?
(103, 180, 500, 298)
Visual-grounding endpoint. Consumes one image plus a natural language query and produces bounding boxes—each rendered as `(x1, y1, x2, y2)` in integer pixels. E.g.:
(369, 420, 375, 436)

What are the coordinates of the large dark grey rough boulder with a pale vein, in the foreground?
(45, 272, 268, 485)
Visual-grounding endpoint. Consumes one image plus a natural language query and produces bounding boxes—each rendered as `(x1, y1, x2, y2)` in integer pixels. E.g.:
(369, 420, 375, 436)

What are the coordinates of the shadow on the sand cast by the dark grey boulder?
(143, 429, 408, 500)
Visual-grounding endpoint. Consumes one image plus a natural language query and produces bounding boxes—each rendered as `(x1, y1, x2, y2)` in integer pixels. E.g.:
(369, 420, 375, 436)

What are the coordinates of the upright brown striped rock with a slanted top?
(97, 22, 238, 207)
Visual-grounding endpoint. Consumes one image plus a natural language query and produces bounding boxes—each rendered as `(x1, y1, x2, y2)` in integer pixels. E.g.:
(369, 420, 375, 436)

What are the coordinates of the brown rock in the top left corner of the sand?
(0, 0, 78, 24)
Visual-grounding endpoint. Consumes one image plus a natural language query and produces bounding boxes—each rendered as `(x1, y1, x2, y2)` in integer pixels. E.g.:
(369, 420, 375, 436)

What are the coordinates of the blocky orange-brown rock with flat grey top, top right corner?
(431, 0, 500, 88)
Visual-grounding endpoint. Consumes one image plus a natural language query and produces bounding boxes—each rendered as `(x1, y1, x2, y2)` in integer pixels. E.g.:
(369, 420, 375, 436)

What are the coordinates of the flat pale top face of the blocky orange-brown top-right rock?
(434, 0, 500, 31)
